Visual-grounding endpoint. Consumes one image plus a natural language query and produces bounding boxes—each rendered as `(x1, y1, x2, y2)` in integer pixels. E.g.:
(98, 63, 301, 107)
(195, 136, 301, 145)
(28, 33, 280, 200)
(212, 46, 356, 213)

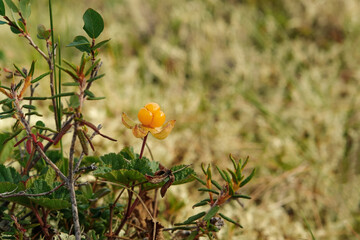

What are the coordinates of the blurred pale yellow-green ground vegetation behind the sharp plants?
(0, 0, 360, 240)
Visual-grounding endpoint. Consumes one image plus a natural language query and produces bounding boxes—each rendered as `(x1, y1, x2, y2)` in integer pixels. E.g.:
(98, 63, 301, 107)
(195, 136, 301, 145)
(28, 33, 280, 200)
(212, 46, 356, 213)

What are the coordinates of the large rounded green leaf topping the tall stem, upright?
(83, 8, 104, 38)
